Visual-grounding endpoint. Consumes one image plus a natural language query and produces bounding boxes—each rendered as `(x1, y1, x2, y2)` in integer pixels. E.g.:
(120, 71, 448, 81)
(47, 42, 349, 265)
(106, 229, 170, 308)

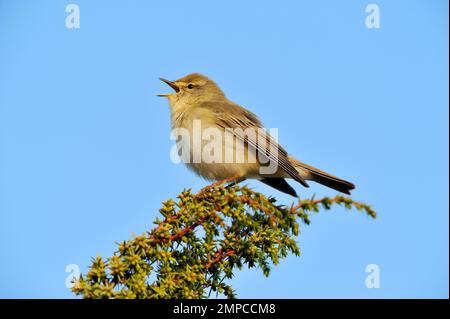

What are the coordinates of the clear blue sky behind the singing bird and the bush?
(0, 0, 449, 298)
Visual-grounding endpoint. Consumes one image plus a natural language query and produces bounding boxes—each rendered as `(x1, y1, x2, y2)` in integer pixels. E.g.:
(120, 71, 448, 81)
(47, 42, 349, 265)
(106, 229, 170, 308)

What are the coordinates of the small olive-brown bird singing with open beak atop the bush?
(158, 73, 355, 196)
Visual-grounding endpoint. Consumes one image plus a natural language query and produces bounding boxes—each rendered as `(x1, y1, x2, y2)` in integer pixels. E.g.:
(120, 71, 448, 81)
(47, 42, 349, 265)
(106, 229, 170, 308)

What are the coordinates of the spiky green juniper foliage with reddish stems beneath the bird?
(72, 184, 376, 298)
